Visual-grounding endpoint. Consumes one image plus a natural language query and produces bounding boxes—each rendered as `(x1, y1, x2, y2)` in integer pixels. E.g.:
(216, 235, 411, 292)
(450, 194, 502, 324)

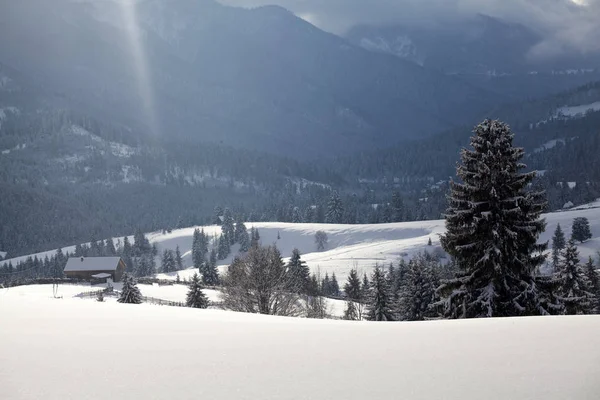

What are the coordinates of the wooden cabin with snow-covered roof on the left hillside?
(64, 257, 125, 282)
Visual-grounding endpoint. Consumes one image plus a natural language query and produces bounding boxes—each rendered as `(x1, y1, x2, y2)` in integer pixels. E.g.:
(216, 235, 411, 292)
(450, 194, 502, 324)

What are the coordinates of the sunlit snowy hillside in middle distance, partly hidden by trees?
(3, 201, 600, 283)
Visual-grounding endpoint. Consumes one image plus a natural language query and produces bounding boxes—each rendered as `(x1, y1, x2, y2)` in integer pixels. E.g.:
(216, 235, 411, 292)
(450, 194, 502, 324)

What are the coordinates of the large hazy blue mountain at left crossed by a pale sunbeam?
(0, 0, 499, 158)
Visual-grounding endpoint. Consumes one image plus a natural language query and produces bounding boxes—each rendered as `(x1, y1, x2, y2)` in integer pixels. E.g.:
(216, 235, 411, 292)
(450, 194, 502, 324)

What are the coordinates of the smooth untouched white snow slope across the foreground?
(0, 294, 600, 400)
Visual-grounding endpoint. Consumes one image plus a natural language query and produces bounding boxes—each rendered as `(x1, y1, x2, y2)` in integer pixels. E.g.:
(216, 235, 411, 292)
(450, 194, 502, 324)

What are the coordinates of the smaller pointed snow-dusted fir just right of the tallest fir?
(556, 239, 595, 315)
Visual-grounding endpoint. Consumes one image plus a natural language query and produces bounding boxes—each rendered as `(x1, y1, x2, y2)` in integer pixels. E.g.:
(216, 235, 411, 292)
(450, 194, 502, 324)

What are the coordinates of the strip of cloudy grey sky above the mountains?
(219, 0, 600, 56)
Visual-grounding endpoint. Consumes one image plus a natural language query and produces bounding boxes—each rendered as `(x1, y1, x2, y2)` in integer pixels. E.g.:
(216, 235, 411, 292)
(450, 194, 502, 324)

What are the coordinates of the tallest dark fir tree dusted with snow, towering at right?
(440, 120, 546, 318)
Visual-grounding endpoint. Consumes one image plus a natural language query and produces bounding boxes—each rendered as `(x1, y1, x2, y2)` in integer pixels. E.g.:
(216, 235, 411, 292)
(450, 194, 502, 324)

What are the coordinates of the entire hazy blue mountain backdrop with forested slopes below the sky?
(0, 0, 600, 255)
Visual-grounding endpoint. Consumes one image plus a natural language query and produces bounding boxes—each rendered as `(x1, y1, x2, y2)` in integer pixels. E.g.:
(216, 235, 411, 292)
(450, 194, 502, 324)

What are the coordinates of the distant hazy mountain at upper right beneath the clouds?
(346, 14, 600, 101)
